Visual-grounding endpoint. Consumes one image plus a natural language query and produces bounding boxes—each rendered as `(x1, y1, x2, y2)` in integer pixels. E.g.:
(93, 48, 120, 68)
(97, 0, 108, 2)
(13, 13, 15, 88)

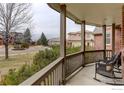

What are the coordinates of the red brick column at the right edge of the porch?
(121, 5, 124, 80)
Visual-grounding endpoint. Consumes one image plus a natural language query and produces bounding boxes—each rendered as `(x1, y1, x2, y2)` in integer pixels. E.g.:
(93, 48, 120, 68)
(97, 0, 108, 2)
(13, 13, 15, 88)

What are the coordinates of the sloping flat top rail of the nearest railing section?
(20, 57, 63, 85)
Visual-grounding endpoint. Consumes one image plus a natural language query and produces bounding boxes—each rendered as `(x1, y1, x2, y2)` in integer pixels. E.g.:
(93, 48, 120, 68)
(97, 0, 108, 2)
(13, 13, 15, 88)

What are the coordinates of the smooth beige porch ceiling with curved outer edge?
(48, 3, 123, 26)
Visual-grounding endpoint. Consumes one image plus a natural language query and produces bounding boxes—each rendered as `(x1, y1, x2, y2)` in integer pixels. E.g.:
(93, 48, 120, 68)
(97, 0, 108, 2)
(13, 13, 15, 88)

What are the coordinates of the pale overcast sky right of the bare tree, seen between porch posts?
(31, 3, 94, 40)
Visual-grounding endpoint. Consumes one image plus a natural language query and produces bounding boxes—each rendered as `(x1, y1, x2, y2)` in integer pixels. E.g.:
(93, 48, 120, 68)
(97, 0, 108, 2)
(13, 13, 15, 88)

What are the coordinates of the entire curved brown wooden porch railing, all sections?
(20, 50, 112, 85)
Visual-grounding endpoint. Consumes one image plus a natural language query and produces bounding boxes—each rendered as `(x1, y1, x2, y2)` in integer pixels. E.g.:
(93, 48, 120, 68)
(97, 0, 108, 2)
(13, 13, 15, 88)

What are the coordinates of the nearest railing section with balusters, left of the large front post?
(20, 57, 63, 85)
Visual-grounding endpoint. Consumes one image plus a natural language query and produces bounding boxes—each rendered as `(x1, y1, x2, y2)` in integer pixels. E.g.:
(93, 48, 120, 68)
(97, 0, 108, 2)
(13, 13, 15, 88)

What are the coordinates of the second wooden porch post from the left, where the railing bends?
(81, 21, 85, 66)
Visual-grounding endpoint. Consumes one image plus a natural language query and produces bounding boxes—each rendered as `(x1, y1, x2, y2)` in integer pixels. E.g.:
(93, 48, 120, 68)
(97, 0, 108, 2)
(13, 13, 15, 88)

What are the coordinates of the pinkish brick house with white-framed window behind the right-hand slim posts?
(94, 27, 121, 51)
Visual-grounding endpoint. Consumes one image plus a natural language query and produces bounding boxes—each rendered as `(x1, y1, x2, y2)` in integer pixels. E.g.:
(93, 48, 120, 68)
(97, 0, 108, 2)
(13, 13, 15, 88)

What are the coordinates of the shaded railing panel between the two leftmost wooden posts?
(65, 52, 84, 78)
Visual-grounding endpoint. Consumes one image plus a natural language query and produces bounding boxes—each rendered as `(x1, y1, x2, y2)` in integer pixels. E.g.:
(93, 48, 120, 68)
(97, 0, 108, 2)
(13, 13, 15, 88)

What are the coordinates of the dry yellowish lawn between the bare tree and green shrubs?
(0, 52, 36, 75)
